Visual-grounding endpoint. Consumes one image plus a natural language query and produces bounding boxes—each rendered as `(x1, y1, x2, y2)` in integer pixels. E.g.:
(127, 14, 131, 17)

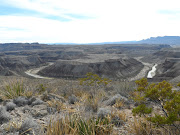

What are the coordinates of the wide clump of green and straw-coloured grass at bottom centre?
(47, 115, 113, 135)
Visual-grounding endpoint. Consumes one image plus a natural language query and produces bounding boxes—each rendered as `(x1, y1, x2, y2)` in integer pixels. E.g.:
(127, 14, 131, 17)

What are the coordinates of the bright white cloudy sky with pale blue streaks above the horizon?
(0, 0, 180, 43)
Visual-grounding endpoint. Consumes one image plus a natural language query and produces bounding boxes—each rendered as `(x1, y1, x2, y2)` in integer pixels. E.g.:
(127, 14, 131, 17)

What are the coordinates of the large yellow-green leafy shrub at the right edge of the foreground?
(132, 78, 180, 134)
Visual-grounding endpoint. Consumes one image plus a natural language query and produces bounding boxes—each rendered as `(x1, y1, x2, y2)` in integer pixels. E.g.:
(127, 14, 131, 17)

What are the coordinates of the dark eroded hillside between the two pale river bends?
(38, 58, 143, 78)
